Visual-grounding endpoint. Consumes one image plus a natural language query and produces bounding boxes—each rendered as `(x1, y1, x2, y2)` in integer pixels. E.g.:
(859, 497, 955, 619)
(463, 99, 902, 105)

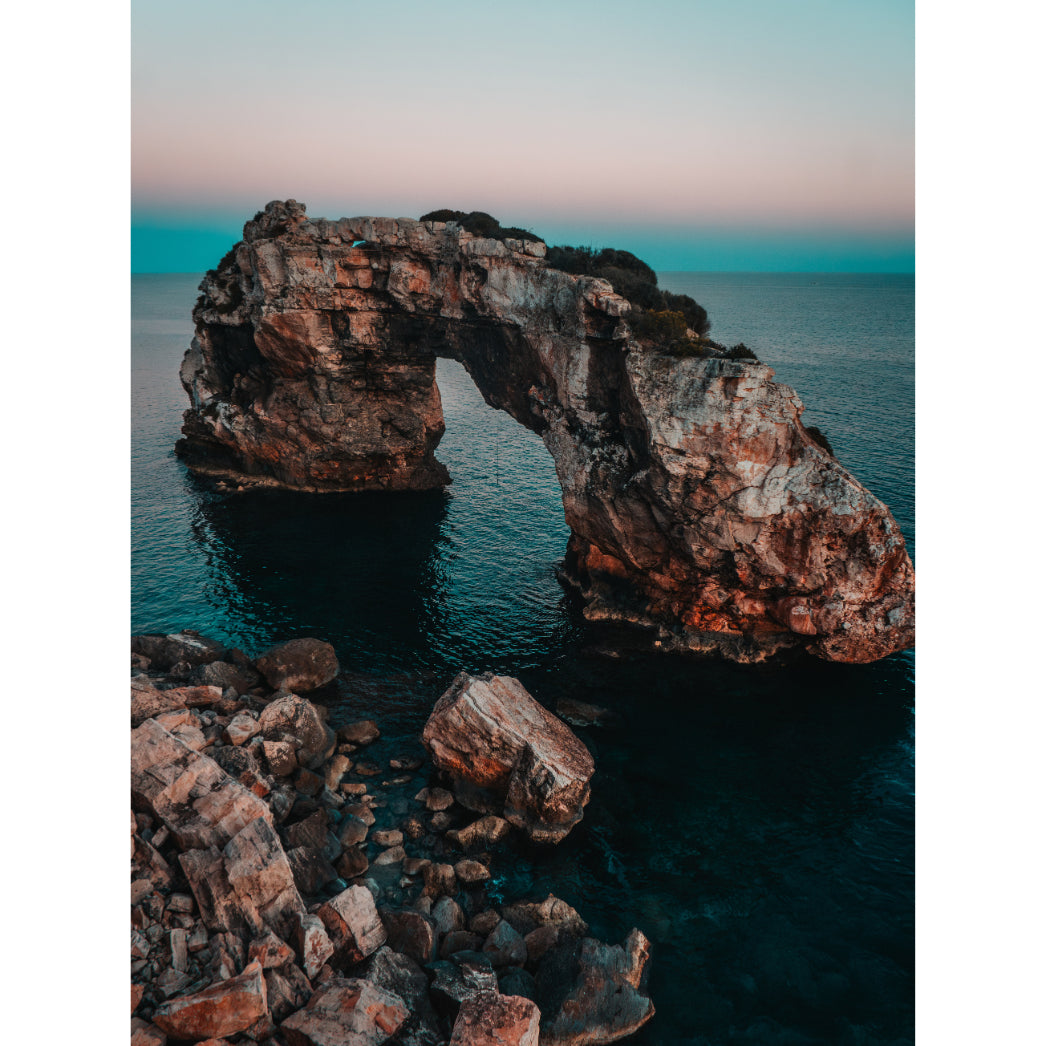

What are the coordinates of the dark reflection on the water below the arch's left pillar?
(186, 477, 449, 670)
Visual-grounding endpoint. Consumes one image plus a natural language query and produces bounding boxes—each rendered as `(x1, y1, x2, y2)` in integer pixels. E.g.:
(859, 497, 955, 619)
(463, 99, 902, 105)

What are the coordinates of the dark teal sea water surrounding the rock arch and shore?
(132, 273, 914, 1046)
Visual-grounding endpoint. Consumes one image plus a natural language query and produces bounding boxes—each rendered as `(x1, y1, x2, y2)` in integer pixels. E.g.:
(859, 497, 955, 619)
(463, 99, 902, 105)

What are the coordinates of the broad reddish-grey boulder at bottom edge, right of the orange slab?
(279, 976, 408, 1046)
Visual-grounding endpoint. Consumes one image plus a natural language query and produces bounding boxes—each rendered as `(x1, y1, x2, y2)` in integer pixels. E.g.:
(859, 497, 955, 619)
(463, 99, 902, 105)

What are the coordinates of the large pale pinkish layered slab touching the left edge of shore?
(131, 720, 272, 849)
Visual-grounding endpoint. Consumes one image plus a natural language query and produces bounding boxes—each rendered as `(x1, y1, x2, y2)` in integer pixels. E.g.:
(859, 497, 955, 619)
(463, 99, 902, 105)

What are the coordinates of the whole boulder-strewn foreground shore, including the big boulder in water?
(131, 631, 654, 1046)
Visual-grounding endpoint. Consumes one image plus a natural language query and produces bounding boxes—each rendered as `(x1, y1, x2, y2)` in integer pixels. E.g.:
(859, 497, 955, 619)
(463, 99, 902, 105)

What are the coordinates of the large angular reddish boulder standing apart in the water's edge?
(422, 673, 595, 842)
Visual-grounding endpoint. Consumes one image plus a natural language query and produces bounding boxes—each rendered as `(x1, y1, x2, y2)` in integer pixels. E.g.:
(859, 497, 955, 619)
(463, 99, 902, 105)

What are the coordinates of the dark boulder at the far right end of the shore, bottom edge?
(536, 930, 654, 1046)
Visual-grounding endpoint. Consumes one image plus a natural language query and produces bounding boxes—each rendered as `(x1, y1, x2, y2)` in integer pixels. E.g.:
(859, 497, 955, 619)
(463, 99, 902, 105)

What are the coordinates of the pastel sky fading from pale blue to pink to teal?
(132, 0, 914, 272)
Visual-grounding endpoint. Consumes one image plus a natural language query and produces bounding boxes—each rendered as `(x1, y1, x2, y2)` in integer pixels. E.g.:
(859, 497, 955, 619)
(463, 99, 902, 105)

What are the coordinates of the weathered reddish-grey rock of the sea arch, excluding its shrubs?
(178, 201, 914, 661)
